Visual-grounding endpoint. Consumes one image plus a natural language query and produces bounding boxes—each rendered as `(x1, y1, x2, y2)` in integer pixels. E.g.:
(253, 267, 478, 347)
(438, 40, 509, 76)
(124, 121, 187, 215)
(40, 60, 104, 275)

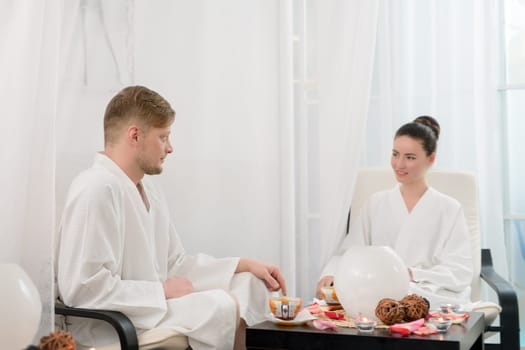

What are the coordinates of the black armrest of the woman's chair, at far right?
(481, 249, 520, 349)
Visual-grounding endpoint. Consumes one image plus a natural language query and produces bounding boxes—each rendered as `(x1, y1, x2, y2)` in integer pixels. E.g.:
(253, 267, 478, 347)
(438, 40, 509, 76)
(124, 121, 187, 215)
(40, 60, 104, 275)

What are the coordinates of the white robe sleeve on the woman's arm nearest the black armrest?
(410, 206, 473, 294)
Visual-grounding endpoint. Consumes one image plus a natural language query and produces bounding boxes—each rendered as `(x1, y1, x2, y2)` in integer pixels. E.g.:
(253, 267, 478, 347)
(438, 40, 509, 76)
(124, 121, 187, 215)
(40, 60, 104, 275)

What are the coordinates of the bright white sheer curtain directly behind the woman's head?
(362, 0, 507, 275)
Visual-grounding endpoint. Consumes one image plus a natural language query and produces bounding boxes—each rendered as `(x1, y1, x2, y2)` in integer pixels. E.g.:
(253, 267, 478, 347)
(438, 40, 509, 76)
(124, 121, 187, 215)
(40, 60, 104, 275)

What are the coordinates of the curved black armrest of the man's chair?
(55, 303, 139, 350)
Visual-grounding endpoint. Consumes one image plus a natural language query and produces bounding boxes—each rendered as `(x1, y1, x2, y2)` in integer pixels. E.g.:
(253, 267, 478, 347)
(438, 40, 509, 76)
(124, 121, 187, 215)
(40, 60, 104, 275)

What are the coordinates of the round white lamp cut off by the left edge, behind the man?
(0, 263, 42, 349)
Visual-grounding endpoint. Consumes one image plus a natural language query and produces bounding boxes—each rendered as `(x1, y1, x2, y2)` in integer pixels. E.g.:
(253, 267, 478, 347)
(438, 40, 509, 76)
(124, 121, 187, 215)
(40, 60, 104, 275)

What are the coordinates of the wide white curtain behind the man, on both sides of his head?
(56, 0, 294, 288)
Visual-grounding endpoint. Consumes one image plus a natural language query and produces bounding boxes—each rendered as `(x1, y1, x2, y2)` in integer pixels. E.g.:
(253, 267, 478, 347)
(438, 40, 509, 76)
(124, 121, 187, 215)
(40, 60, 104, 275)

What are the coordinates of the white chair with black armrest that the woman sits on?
(347, 168, 519, 349)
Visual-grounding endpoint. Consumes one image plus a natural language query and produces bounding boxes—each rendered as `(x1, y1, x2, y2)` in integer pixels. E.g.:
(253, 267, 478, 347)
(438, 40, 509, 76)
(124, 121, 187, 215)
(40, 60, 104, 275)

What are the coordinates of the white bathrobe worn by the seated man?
(57, 154, 268, 350)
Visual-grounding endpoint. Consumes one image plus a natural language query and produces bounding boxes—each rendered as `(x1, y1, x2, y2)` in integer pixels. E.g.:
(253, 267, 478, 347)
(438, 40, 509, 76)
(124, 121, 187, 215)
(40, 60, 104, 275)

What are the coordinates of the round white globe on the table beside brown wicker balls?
(334, 246, 410, 320)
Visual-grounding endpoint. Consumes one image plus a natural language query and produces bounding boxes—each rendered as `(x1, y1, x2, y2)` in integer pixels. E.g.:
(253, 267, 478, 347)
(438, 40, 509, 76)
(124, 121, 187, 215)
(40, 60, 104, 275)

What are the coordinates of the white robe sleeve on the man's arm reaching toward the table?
(168, 225, 239, 291)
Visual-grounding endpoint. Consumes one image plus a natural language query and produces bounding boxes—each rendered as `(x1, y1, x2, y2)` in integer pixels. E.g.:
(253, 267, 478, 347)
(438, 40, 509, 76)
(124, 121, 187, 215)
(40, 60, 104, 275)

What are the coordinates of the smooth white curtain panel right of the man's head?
(135, 0, 280, 263)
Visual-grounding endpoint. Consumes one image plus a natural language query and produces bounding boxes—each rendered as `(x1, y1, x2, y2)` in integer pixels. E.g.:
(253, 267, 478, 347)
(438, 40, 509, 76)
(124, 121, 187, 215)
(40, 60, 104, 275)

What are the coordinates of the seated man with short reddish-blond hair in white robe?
(57, 86, 286, 350)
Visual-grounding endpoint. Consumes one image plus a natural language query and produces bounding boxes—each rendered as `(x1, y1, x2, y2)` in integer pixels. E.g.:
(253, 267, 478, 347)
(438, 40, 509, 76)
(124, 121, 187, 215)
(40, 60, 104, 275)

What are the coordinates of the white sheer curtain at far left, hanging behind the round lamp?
(0, 0, 62, 345)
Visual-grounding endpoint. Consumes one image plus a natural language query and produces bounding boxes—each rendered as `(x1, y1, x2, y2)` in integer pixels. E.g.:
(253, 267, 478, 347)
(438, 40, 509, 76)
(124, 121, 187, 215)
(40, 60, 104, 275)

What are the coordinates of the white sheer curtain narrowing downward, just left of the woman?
(310, 0, 379, 295)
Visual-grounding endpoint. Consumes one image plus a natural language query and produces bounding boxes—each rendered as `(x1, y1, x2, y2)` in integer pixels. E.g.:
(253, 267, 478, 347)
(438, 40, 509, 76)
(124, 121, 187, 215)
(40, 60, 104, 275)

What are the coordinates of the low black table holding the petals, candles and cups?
(246, 312, 485, 350)
